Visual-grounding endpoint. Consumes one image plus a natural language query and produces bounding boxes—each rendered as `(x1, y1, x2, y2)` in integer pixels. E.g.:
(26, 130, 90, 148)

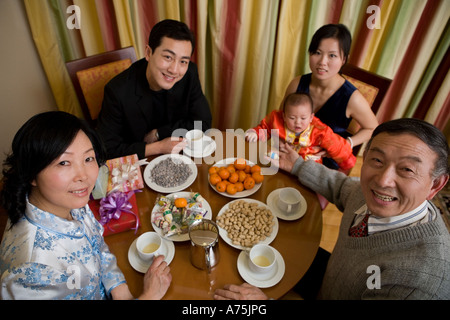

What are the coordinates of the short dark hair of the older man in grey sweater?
(366, 118, 450, 178)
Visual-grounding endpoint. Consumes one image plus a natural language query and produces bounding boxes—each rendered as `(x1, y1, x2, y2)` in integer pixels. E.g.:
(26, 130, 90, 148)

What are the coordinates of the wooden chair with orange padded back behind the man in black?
(66, 47, 136, 126)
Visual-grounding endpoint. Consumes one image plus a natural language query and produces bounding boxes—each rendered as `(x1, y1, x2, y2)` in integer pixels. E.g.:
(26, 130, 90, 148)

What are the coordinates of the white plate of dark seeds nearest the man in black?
(144, 154, 197, 193)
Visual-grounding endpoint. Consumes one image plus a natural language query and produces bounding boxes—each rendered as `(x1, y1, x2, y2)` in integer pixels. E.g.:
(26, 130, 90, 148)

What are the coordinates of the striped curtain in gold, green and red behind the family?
(24, 0, 450, 140)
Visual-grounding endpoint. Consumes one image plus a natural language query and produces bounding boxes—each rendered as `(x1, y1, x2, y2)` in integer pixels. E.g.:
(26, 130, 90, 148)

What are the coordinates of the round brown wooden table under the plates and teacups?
(105, 131, 322, 300)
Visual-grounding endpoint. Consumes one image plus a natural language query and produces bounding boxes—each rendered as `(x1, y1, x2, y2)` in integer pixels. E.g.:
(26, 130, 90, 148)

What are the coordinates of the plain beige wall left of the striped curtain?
(0, 0, 56, 176)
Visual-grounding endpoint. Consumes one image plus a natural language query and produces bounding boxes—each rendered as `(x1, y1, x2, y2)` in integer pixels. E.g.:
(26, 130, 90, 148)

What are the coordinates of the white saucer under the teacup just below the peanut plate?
(237, 247, 285, 288)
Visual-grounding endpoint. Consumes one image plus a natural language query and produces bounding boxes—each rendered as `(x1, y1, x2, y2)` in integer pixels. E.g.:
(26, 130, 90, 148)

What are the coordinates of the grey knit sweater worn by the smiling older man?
(291, 158, 450, 300)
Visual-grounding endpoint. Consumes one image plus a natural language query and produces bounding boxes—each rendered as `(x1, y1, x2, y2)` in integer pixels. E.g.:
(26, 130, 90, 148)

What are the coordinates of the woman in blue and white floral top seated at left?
(0, 111, 171, 299)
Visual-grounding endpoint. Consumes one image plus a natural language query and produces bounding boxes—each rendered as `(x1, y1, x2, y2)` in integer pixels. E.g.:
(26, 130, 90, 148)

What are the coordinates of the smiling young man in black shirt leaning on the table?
(97, 20, 212, 159)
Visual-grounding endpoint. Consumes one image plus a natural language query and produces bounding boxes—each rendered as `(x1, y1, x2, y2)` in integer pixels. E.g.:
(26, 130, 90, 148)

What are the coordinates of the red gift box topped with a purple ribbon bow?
(89, 190, 140, 236)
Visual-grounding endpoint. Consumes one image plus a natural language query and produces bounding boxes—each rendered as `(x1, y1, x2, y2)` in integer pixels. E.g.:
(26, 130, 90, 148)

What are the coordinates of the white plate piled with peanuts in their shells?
(216, 199, 278, 250)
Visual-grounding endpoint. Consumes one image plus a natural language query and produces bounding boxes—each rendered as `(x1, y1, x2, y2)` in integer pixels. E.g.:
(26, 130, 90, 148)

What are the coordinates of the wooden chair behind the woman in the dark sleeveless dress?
(317, 64, 392, 210)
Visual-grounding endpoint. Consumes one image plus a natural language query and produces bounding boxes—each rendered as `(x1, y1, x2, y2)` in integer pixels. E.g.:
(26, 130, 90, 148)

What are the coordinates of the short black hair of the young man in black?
(148, 19, 195, 55)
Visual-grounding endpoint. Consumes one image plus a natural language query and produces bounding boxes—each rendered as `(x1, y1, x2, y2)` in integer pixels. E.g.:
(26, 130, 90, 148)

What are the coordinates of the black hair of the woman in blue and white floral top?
(0, 111, 106, 226)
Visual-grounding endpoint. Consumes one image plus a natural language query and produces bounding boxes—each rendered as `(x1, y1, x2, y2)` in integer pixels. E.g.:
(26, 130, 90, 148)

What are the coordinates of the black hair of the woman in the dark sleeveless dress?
(308, 24, 352, 63)
